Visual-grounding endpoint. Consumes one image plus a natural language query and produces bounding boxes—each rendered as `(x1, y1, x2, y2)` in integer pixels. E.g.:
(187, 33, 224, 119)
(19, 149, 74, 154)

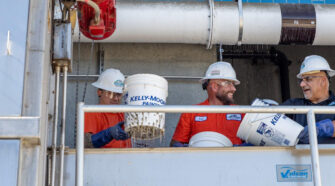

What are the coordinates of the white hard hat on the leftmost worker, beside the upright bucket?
(92, 68, 124, 93)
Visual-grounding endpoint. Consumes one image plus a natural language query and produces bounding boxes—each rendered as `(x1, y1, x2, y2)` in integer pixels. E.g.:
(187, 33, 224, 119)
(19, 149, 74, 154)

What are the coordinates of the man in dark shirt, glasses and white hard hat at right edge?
(283, 55, 335, 144)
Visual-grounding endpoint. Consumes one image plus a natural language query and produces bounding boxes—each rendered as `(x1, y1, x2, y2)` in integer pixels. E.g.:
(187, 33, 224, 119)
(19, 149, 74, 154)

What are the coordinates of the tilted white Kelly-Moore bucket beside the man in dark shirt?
(237, 99, 303, 146)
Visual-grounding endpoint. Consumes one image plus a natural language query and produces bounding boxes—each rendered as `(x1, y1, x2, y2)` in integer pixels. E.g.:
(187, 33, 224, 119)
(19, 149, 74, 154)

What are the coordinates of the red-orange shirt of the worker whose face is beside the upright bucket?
(85, 113, 131, 148)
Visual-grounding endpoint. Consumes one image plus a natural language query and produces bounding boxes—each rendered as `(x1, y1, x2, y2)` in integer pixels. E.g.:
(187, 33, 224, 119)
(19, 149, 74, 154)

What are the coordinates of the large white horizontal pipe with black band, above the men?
(74, 0, 335, 47)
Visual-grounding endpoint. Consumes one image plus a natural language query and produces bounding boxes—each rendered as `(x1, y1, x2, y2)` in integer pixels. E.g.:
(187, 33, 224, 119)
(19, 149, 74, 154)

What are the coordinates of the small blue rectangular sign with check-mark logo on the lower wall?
(276, 165, 312, 182)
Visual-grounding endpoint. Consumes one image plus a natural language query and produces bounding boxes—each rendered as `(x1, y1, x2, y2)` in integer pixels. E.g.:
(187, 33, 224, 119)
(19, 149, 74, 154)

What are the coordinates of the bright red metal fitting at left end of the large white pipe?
(78, 0, 116, 40)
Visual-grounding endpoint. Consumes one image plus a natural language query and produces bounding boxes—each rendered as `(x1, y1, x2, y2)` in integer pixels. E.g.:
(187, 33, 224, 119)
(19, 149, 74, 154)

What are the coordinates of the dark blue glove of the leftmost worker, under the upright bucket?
(91, 121, 129, 148)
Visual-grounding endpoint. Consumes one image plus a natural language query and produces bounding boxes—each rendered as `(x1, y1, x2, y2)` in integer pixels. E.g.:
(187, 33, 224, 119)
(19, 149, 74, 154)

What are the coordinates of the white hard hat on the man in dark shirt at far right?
(297, 55, 335, 78)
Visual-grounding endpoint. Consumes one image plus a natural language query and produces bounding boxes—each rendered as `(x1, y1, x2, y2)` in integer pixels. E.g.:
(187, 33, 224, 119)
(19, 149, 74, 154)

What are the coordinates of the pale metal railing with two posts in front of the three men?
(76, 102, 335, 186)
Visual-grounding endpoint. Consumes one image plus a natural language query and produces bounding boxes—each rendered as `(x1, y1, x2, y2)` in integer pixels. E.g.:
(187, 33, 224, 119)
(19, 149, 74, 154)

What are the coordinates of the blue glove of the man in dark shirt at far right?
(298, 119, 334, 144)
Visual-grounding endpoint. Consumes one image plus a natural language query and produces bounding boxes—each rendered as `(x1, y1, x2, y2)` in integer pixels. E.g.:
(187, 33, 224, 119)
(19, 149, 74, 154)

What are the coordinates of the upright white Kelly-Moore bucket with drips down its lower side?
(124, 74, 168, 139)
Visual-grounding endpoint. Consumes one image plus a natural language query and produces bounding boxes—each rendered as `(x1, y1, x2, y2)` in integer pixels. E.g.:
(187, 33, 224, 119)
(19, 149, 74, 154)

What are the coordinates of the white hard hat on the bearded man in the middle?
(200, 62, 240, 85)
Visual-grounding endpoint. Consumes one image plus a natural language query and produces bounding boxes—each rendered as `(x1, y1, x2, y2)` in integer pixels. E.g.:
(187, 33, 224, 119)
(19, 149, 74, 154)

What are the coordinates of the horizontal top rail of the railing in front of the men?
(82, 105, 335, 114)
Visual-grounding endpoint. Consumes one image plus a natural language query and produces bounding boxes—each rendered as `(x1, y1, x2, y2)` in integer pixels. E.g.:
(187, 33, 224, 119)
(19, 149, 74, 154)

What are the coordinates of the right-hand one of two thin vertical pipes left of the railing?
(59, 66, 68, 186)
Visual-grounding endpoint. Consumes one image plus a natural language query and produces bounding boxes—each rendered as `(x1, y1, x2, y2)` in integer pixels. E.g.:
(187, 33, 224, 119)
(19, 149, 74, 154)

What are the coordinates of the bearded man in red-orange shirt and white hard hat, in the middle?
(170, 62, 244, 147)
